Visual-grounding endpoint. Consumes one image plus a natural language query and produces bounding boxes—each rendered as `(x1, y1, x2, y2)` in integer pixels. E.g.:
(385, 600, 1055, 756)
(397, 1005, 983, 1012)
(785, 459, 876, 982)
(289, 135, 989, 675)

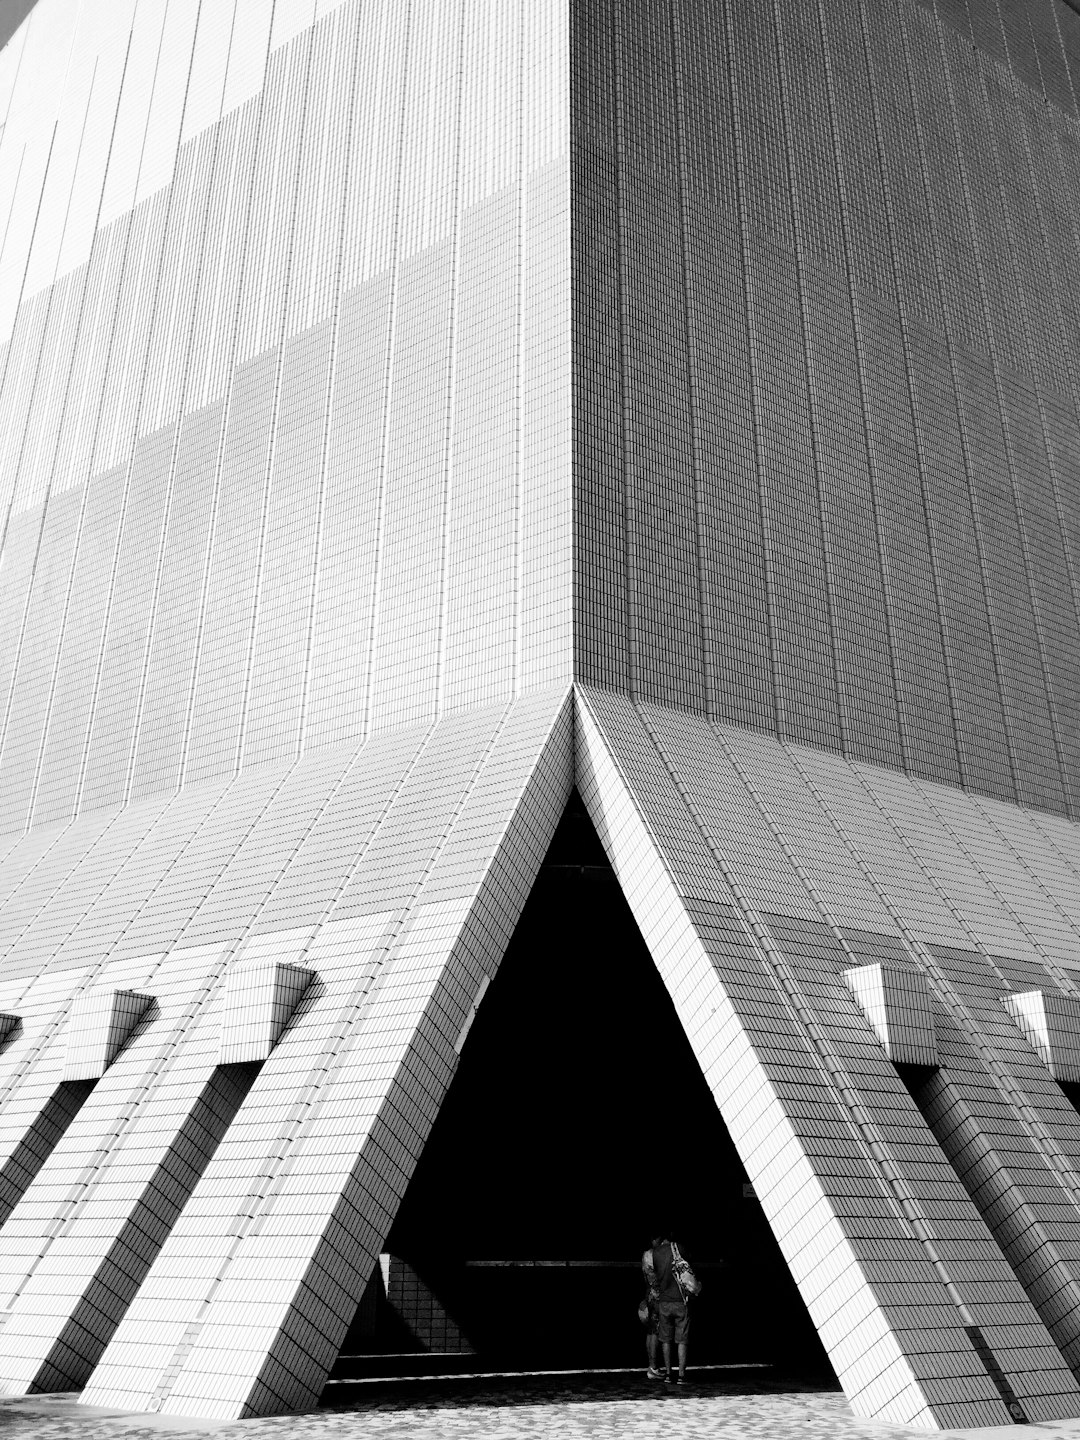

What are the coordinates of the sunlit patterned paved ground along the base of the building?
(0, 1372, 1080, 1440)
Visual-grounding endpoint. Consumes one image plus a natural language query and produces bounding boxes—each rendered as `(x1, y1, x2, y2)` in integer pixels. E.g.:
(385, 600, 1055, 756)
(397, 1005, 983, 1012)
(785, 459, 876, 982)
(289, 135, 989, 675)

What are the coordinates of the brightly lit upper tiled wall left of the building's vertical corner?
(0, 0, 570, 831)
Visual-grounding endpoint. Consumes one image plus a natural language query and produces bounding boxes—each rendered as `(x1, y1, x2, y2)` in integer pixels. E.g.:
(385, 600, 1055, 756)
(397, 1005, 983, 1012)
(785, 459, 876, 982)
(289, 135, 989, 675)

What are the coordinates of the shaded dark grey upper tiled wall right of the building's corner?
(572, 0, 1080, 814)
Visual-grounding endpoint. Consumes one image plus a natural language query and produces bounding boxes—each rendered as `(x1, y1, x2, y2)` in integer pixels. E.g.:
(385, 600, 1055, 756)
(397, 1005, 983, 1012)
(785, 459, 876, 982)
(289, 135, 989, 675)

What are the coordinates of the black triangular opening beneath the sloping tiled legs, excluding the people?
(338, 793, 832, 1377)
